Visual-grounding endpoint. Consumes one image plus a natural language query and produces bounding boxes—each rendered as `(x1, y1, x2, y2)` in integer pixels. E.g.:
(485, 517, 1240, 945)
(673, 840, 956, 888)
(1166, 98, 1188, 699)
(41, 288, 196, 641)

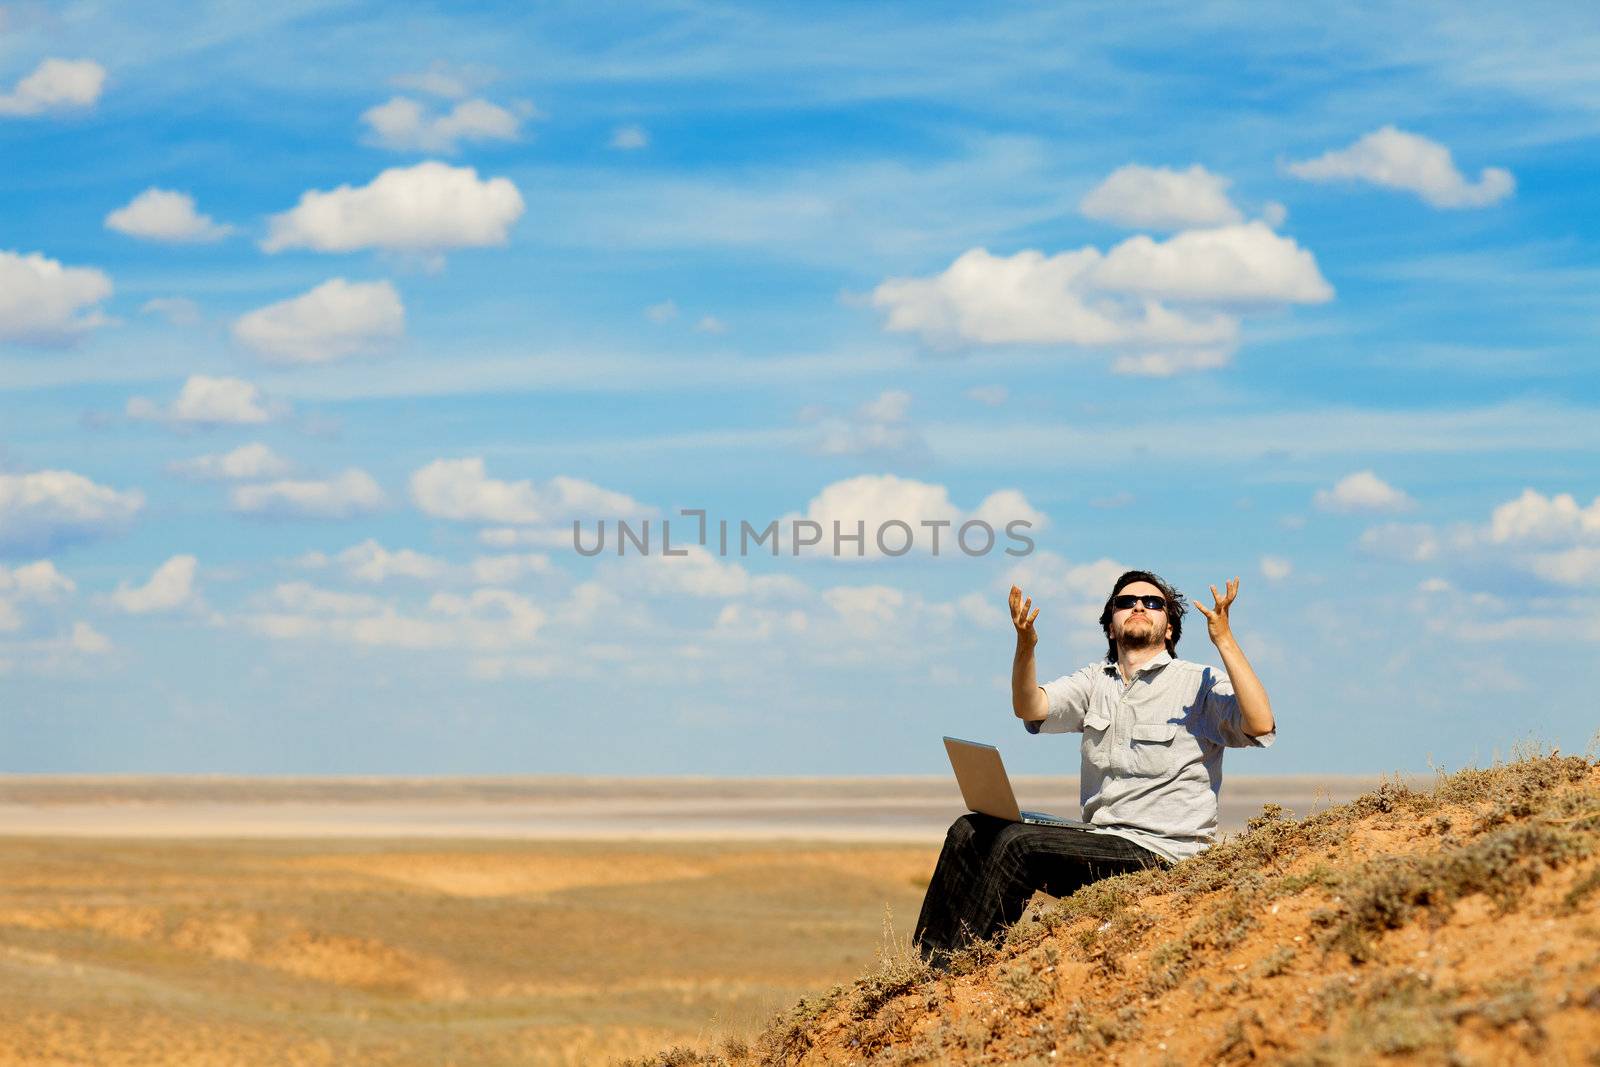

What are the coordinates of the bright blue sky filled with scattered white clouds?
(0, 0, 1600, 774)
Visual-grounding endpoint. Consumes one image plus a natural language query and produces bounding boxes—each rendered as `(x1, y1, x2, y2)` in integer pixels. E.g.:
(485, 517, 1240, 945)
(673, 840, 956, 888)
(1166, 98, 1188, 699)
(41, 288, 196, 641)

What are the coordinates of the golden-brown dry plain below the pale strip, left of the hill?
(0, 838, 933, 1067)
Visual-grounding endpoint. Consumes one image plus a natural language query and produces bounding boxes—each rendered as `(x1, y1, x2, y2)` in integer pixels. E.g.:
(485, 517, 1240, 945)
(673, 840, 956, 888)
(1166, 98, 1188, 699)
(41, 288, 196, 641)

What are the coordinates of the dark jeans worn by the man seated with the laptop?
(915, 814, 1166, 961)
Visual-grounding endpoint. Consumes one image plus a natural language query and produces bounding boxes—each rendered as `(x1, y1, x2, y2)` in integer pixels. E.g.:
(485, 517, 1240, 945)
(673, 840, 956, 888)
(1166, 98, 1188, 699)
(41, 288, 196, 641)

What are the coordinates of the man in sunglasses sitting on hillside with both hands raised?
(915, 571, 1277, 961)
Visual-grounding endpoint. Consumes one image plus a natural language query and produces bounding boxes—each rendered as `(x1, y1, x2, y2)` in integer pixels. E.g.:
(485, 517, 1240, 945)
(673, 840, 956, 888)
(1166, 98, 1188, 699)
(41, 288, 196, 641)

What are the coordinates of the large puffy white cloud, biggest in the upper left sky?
(261, 160, 523, 253)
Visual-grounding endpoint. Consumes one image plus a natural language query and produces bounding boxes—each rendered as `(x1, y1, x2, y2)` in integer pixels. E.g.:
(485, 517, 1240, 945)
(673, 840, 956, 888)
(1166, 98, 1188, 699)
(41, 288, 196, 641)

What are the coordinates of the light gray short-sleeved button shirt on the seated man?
(1024, 649, 1277, 862)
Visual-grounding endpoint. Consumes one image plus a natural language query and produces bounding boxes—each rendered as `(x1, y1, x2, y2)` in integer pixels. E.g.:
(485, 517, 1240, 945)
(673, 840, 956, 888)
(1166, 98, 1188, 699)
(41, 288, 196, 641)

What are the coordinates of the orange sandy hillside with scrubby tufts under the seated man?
(635, 755, 1600, 1067)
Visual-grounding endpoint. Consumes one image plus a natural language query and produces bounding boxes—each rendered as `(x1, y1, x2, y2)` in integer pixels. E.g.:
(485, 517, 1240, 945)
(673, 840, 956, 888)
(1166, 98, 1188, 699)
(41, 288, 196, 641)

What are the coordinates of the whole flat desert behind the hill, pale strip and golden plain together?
(0, 777, 1374, 1067)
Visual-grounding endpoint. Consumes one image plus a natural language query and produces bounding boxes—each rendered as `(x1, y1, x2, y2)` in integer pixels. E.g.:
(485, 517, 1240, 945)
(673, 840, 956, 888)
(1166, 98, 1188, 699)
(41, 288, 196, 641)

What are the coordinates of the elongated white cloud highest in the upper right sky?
(1285, 126, 1517, 208)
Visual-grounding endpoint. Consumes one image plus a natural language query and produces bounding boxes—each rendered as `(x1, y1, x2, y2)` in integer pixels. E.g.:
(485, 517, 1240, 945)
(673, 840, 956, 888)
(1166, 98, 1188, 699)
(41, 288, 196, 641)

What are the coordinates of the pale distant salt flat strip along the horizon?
(0, 776, 1408, 841)
